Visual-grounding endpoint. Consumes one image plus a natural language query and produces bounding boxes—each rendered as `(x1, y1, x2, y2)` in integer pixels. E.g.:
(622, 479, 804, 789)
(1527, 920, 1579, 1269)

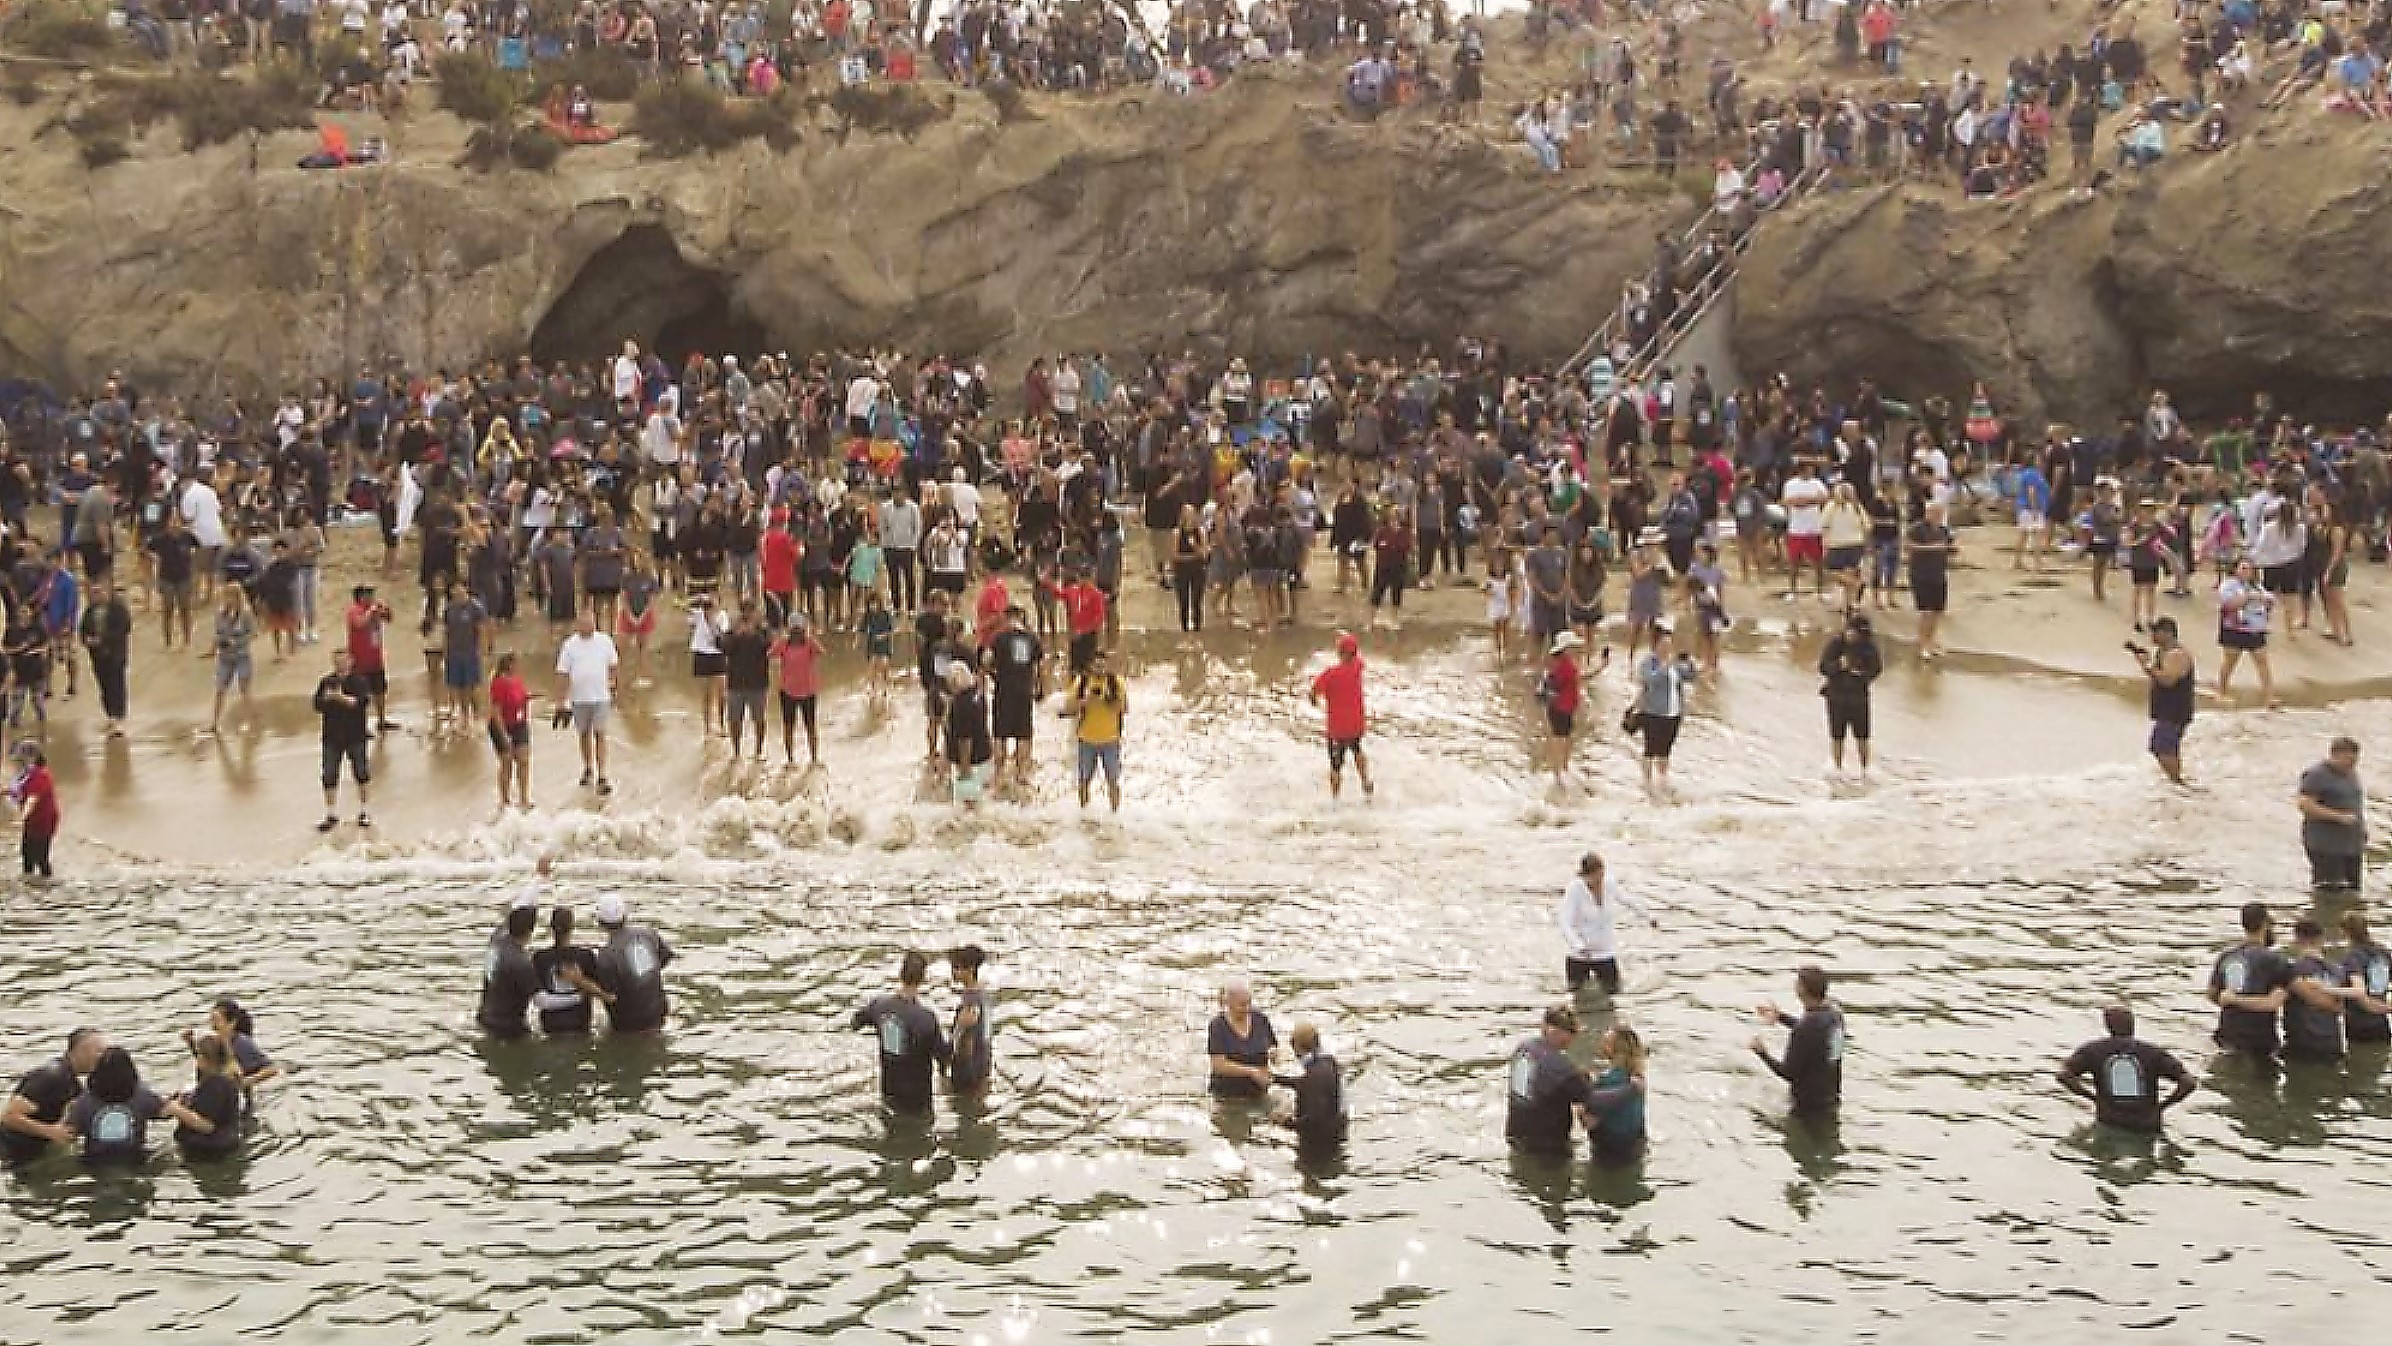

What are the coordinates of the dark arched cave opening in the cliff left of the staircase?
(531, 225, 768, 363)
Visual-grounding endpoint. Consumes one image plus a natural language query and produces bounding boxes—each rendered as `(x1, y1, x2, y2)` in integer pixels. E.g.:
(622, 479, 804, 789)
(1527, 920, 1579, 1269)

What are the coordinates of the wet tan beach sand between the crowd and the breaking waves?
(23, 524, 2392, 875)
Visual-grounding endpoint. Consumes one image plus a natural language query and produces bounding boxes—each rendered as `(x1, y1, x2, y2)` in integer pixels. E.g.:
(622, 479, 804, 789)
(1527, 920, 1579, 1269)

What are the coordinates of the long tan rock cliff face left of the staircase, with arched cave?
(0, 72, 1689, 387)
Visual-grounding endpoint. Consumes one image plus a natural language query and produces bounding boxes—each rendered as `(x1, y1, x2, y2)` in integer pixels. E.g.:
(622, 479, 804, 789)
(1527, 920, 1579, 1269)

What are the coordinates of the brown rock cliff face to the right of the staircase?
(1737, 121, 2392, 423)
